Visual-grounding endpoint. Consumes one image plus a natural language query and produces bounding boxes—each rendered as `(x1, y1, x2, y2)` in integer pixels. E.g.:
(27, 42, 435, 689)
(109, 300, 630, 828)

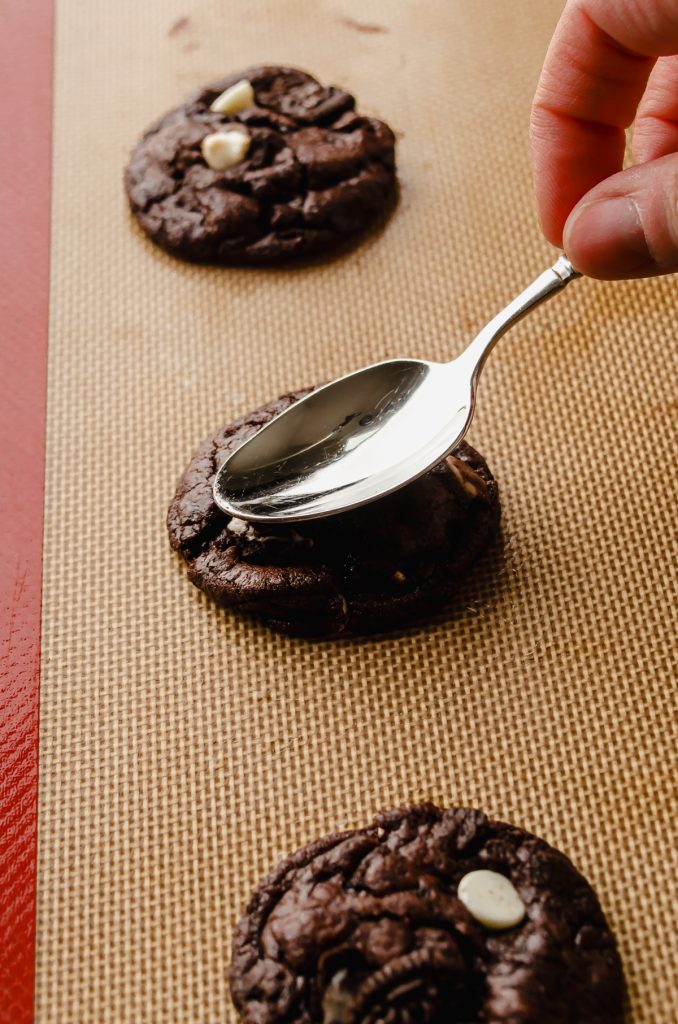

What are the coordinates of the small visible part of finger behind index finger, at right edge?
(633, 56, 678, 163)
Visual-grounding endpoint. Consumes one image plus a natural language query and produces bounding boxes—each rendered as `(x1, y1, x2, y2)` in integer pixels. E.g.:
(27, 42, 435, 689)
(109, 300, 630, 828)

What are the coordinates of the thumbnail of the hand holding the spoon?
(564, 196, 654, 278)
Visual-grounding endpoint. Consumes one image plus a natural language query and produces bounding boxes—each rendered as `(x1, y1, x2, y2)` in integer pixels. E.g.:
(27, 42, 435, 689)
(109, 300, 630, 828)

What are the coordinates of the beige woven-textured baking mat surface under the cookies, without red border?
(37, 0, 678, 1024)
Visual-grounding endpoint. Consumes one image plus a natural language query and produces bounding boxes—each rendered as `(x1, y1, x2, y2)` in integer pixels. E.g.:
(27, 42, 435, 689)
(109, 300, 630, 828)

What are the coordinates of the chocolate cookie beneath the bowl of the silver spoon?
(167, 390, 499, 636)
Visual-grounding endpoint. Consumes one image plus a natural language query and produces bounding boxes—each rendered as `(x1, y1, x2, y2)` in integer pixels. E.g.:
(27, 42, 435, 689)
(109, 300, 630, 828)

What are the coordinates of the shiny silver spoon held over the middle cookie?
(214, 256, 580, 523)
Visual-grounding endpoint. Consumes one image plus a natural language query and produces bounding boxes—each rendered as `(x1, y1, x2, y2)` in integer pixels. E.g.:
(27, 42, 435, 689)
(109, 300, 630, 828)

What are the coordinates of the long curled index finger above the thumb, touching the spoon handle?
(531, 0, 678, 245)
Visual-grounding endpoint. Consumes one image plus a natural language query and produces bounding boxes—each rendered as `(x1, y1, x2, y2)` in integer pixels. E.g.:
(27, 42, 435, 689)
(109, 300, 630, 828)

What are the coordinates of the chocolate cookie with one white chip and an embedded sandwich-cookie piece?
(230, 804, 624, 1024)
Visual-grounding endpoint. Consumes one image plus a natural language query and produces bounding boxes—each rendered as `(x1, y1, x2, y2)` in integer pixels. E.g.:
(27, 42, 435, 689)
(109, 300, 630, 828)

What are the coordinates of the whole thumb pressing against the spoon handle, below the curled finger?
(563, 154, 678, 281)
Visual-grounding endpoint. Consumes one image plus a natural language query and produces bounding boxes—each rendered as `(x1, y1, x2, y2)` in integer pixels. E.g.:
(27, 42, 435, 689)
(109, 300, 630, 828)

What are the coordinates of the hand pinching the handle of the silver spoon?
(531, 0, 678, 280)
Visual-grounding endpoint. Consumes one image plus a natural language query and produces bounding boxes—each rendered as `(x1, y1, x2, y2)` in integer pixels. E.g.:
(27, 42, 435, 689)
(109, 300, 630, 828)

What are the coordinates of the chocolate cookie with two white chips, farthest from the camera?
(125, 68, 395, 263)
